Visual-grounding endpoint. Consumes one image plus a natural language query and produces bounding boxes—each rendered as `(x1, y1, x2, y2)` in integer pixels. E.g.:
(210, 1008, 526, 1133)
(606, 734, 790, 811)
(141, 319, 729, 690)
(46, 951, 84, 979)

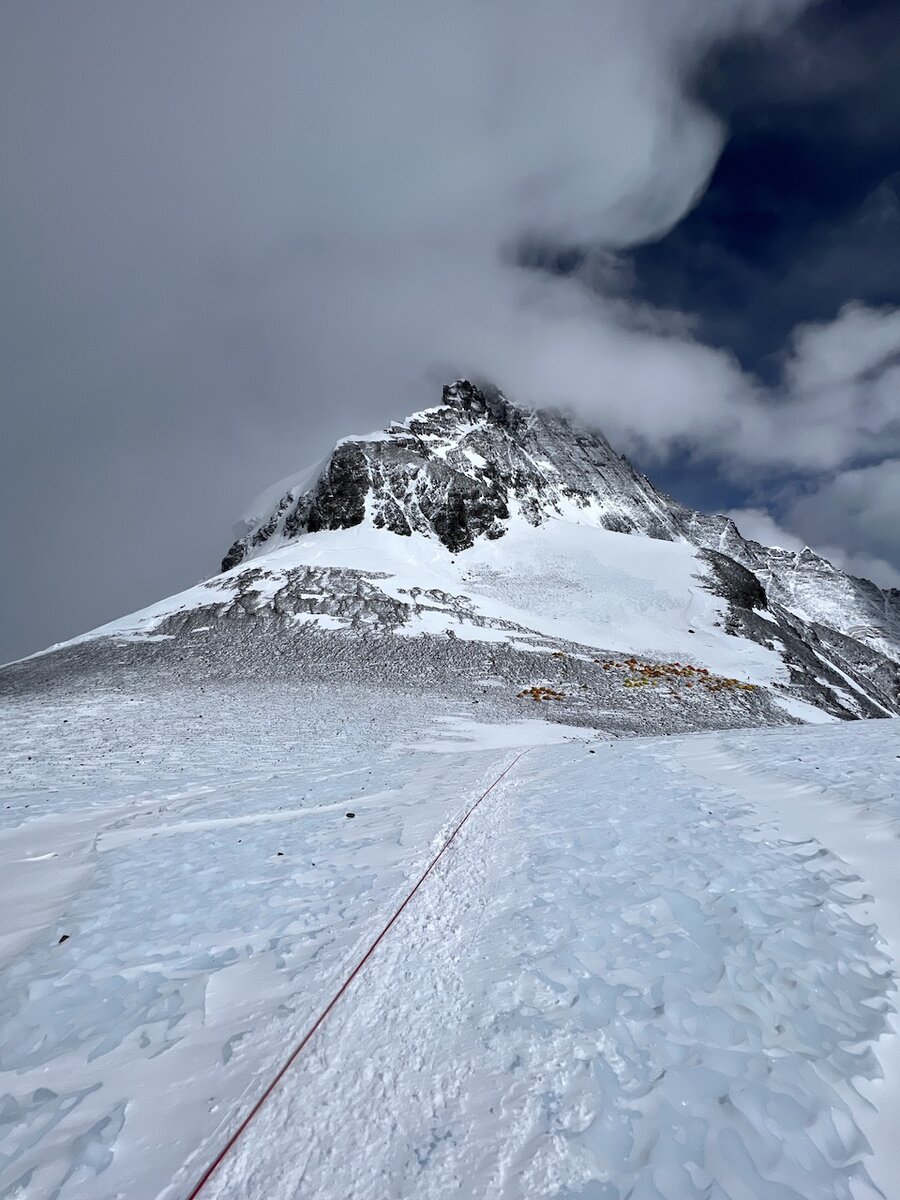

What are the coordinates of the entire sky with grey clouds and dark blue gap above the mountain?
(0, 0, 900, 660)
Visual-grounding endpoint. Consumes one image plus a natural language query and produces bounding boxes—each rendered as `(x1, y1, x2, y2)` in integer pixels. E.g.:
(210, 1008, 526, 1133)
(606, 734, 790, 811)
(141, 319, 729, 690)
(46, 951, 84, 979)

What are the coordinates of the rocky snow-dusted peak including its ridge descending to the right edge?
(222, 379, 900, 710)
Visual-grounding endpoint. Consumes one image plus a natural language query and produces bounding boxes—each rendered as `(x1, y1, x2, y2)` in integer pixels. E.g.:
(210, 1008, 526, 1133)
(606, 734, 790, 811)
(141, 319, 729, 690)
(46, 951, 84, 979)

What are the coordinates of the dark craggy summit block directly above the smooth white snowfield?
(222, 379, 682, 570)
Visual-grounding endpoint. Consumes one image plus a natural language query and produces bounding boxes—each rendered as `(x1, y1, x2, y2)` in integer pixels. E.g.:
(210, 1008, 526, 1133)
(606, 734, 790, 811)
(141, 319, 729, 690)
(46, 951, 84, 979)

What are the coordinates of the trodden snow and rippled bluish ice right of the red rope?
(188, 720, 889, 1200)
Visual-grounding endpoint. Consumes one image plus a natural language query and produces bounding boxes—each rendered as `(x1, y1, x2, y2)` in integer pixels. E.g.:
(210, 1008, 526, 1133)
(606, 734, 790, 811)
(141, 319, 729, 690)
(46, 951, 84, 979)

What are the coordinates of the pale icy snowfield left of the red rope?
(0, 688, 542, 1200)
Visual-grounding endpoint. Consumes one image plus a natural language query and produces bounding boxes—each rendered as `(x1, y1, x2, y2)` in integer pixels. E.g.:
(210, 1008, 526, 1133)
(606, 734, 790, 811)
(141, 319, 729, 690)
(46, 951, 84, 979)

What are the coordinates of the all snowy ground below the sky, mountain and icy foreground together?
(0, 384, 900, 1200)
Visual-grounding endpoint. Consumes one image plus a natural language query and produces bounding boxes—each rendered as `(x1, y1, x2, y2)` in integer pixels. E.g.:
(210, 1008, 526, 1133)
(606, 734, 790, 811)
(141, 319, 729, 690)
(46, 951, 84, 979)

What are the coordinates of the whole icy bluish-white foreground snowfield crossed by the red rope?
(0, 684, 900, 1200)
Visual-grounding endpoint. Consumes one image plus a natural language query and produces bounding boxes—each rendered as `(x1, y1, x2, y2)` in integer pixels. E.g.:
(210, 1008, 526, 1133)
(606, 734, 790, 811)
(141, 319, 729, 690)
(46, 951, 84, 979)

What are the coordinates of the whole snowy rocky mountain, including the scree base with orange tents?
(0, 380, 900, 732)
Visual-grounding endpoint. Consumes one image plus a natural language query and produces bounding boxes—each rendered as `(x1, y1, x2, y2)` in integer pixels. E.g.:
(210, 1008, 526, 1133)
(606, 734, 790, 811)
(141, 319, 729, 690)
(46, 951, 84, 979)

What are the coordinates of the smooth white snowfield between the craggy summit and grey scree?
(64, 520, 768, 682)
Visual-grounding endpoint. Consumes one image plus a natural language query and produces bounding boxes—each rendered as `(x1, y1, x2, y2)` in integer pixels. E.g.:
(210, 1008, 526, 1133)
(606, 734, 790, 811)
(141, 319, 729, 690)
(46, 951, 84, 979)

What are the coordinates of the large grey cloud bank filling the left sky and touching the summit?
(0, 0, 889, 655)
